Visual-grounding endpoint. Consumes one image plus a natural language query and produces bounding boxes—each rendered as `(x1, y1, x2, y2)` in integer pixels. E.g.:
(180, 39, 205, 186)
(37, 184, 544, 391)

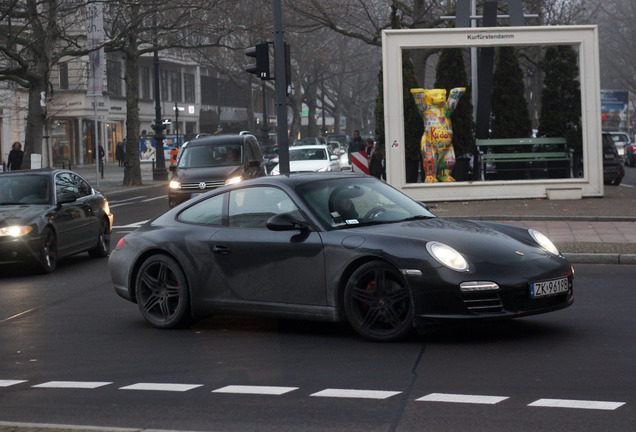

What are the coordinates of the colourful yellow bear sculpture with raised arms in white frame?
(411, 87, 466, 183)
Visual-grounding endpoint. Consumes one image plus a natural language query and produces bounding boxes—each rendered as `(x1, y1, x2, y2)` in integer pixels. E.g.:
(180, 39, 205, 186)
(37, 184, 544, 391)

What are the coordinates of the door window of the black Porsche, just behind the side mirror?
(229, 187, 304, 229)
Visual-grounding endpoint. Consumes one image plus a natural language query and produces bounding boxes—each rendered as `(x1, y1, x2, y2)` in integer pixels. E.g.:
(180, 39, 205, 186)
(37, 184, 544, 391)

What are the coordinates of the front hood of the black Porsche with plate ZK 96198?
(351, 218, 549, 264)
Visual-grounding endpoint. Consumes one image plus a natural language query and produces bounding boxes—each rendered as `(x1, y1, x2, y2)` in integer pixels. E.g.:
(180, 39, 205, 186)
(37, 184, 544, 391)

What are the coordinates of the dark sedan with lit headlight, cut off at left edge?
(0, 169, 113, 273)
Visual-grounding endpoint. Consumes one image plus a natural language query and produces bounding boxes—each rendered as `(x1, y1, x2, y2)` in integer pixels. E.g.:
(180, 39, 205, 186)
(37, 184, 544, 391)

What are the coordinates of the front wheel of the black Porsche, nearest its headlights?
(344, 261, 413, 342)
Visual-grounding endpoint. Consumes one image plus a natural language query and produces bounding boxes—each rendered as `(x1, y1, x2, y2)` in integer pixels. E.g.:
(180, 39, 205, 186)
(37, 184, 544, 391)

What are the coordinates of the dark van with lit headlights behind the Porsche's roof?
(168, 134, 267, 208)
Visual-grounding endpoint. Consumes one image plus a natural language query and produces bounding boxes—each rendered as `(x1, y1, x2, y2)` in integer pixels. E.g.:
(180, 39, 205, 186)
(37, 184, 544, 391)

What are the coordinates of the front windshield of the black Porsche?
(296, 177, 435, 228)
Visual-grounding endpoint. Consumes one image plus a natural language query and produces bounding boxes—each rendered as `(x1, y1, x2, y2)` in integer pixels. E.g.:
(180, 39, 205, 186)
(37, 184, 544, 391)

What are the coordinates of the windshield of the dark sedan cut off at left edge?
(0, 175, 51, 205)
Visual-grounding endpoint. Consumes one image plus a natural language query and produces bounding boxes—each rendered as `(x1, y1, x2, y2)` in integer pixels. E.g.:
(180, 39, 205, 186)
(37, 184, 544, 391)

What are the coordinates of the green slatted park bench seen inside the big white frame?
(476, 138, 574, 180)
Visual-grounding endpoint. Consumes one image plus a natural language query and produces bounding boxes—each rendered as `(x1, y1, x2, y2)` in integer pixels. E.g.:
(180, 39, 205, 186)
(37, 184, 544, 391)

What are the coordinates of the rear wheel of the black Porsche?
(135, 255, 190, 329)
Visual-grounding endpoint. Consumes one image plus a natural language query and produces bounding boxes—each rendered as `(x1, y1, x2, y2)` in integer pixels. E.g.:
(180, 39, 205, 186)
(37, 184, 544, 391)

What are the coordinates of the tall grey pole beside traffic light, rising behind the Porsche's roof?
(272, 0, 289, 174)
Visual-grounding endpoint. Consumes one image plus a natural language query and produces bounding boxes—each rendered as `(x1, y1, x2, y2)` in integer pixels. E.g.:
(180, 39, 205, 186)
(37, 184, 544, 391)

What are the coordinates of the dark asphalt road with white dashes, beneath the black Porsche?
(0, 189, 636, 432)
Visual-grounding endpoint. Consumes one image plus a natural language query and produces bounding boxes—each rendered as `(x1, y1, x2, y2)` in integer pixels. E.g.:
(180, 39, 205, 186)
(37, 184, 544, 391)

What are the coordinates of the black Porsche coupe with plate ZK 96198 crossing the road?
(109, 173, 574, 341)
